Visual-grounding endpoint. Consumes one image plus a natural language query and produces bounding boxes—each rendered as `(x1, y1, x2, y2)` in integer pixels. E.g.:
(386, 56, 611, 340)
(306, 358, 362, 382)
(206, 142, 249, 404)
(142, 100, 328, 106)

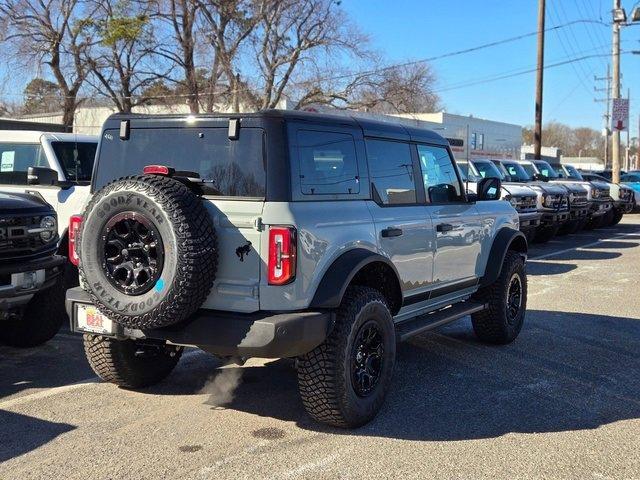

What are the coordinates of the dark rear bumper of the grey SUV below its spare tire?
(66, 287, 333, 358)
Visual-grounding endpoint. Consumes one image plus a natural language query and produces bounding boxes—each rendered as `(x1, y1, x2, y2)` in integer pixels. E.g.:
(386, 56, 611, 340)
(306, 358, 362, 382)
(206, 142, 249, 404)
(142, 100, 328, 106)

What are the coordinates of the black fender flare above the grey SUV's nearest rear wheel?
(310, 248, 402, 308)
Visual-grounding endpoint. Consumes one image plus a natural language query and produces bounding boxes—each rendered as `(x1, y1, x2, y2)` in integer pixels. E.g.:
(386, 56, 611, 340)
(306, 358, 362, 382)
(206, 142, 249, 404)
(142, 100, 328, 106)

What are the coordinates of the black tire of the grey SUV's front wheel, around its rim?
(471, 250, 527, 345)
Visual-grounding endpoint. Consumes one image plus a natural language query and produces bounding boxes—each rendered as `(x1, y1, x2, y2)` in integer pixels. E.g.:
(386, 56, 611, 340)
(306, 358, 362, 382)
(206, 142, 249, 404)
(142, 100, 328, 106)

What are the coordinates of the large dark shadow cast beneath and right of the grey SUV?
(154, 311, 640, 441)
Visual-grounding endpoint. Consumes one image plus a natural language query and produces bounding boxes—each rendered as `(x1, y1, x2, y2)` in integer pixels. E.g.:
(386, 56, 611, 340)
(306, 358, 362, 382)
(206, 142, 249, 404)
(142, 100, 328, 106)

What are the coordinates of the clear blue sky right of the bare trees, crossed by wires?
(342, 0, 640, 135)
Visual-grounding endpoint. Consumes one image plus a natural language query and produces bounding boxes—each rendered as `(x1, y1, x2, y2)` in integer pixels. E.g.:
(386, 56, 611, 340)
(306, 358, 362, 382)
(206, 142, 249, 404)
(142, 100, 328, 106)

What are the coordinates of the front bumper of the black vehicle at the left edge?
(0, 255, 66, 311)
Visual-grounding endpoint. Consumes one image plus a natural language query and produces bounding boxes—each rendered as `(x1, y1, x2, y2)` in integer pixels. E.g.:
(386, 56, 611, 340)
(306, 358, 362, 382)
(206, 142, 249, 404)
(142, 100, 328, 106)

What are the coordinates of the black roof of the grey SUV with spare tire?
(105, 110, 449, 145)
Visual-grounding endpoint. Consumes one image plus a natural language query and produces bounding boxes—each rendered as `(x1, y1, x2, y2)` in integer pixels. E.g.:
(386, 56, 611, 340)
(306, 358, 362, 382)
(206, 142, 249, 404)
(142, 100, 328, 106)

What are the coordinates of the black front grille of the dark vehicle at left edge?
(0, 215, 56, 261)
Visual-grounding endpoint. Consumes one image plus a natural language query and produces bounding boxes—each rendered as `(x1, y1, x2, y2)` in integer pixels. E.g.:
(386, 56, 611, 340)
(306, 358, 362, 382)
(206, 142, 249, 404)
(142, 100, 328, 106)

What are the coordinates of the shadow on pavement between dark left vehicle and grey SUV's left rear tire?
(0, 333, 95, 399)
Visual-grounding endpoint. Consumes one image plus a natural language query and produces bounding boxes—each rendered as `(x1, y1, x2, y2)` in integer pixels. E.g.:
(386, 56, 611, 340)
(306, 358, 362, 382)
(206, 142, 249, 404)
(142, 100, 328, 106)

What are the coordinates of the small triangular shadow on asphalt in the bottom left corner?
(0, 410, 76, 464)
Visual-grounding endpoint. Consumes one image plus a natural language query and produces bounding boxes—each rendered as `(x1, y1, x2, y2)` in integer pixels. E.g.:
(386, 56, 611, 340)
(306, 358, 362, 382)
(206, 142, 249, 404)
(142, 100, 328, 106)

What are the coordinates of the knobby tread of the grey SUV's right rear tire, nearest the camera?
(298, 286, 389, 428)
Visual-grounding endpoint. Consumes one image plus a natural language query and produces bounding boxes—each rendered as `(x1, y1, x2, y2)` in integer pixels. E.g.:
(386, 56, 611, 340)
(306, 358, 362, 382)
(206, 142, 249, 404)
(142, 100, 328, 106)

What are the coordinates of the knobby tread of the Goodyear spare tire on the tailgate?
(78, 175, 218, 329)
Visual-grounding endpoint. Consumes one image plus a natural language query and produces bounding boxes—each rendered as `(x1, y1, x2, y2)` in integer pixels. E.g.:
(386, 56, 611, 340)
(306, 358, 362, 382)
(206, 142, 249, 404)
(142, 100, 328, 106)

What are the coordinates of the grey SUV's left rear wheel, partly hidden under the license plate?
(84, 334, 182, 388)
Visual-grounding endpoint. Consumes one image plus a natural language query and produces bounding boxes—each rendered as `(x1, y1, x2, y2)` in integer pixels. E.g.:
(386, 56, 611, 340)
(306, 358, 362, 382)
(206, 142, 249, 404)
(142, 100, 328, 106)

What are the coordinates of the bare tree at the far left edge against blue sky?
(0, 0, 91, 126)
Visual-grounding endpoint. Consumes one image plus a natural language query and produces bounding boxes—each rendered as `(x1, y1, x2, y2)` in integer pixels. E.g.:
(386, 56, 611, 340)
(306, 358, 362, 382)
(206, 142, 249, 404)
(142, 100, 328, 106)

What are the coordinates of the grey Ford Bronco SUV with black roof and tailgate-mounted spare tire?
(67, 111, 527, 428)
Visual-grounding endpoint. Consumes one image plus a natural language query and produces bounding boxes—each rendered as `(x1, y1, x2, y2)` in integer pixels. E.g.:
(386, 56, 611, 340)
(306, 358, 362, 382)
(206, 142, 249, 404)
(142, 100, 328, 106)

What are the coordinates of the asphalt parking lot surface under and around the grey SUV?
(0, 215, 640, 479)
